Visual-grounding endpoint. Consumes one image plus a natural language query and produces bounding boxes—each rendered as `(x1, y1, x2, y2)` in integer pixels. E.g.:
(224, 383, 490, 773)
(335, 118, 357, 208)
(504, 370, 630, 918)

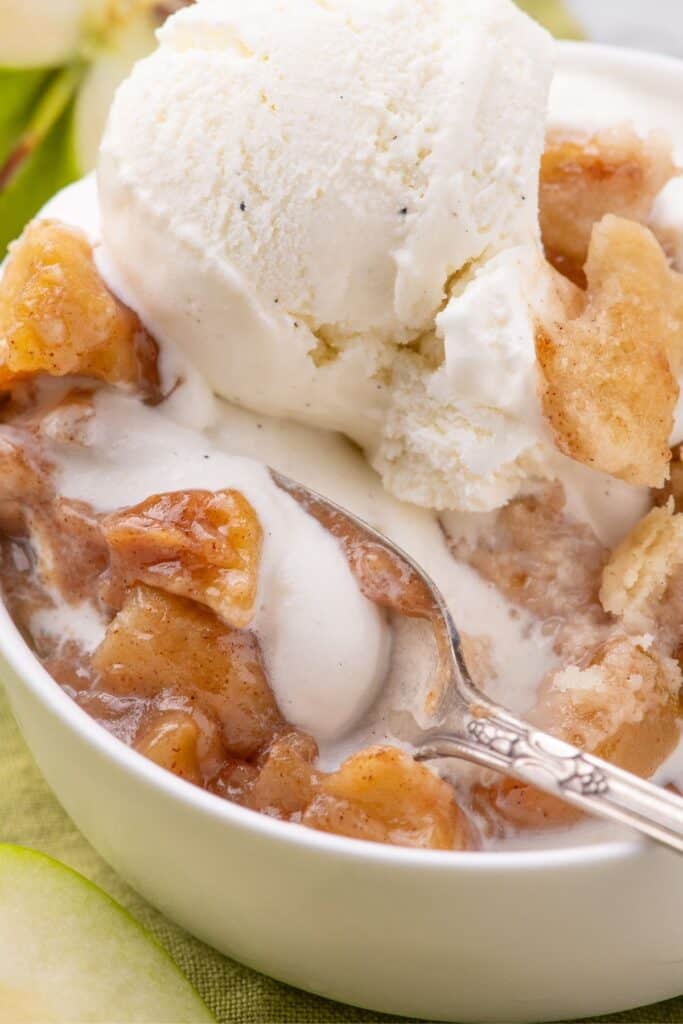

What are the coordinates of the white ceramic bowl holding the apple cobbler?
(0, 39, 683, 1024)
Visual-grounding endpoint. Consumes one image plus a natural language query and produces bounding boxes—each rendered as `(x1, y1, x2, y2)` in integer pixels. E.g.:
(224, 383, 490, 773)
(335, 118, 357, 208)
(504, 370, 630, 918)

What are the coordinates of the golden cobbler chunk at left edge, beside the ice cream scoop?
(0, 220, 159, 398)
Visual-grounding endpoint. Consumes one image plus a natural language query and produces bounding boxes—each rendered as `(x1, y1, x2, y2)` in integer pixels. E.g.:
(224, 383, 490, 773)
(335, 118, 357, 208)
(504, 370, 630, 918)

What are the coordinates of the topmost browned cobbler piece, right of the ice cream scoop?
(540, 125, 676, 285)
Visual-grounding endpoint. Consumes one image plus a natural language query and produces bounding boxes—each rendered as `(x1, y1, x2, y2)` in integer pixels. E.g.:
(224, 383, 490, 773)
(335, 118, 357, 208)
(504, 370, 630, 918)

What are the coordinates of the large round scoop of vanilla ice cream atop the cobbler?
(98, 0, 553, 509)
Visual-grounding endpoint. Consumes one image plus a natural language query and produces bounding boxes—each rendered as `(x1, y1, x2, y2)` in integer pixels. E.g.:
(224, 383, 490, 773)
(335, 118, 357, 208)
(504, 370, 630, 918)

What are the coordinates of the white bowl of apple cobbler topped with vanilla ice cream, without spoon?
(2, 3, 682, 1020)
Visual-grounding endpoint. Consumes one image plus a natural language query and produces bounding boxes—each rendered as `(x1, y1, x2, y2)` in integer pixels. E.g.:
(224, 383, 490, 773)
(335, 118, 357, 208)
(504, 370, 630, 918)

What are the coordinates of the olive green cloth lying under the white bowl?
(0, 0, 683, 1024)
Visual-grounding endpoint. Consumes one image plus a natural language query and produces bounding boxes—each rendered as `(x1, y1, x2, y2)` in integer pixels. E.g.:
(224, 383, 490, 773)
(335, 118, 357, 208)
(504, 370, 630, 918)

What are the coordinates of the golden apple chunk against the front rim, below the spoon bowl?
(302, 746, 472, 850)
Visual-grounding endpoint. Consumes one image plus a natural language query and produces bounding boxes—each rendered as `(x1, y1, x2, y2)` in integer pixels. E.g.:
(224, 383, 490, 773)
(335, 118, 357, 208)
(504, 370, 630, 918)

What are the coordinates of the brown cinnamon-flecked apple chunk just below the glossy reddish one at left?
(92, 586, 282, 758)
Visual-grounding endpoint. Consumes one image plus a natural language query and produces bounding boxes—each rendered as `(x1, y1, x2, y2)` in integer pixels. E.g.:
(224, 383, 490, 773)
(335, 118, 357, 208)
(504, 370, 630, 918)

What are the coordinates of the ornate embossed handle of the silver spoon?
(416, 700, 683, 853)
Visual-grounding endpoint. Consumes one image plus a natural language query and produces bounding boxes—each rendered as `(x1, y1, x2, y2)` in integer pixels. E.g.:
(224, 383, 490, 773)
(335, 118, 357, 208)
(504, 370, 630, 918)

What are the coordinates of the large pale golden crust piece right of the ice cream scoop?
(537, 216, 683, 486)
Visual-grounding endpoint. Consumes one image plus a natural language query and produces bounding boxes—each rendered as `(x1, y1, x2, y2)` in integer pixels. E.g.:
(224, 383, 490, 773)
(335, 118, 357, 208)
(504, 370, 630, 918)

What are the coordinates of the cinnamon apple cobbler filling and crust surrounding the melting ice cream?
(0, 123, 683, 849)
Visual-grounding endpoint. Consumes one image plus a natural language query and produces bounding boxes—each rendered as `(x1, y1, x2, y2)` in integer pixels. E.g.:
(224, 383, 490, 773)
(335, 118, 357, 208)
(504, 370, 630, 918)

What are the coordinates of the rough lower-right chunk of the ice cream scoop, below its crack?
(374, 244, 555, 511)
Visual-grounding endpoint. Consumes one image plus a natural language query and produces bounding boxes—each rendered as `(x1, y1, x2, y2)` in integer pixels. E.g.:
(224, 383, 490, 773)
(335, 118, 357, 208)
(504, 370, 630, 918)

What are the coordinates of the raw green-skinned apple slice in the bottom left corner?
(0, 844, 215, 1024)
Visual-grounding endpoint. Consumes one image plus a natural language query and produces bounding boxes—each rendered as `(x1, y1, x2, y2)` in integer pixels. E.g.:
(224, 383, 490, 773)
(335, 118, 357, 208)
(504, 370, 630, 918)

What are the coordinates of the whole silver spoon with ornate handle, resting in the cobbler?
(271, 470, 683, 853)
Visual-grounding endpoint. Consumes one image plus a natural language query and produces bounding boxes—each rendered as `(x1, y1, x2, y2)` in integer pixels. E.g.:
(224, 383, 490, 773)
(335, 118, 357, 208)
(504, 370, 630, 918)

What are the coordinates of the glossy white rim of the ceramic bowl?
(0, 42, 683, 872)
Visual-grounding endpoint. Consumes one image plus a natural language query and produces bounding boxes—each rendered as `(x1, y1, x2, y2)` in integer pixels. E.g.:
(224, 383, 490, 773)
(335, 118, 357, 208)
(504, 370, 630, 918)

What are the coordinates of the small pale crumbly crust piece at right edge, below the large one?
(600, 501, 683, 630)
